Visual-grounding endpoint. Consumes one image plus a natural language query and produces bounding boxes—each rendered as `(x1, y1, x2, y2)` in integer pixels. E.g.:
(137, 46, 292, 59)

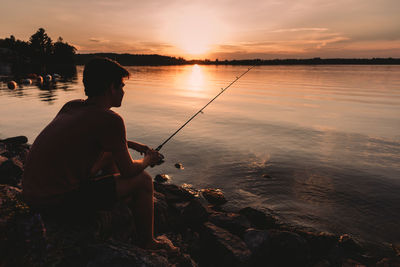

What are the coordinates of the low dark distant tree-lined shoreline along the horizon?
(75, 53, 400, 66)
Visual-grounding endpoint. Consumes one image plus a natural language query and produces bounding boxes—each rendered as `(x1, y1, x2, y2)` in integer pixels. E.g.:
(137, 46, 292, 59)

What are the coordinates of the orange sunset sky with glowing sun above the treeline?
(0, 0, 400, 60)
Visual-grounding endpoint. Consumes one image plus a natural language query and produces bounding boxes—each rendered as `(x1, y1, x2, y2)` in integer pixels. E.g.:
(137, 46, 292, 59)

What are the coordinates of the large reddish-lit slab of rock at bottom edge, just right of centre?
(200, 222, 251, 266)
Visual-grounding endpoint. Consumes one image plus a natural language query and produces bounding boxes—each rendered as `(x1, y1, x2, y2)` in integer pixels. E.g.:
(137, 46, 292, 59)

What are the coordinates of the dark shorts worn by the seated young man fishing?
(36, 175, 118, 219)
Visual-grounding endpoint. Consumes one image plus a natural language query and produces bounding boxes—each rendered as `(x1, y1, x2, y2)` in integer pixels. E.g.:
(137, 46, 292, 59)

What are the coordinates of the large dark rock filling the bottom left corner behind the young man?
(0, 185, 47, 266)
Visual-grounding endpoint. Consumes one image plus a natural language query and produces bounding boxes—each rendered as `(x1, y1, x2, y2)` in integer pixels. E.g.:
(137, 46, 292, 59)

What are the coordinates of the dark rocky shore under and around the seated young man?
(0, 136, 400, 267)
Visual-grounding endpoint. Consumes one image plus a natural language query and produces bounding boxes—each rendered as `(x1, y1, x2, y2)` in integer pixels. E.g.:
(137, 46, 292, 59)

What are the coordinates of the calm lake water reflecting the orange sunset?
(0, 65, 400, 247)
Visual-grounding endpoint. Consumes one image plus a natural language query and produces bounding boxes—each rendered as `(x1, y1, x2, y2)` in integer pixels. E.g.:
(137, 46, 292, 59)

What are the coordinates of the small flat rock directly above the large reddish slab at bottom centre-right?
(209, 212, 250, 236)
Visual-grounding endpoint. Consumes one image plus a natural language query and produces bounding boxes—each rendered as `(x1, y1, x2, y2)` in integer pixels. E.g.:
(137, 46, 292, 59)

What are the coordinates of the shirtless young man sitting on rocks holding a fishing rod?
(23, 58, 163, 248)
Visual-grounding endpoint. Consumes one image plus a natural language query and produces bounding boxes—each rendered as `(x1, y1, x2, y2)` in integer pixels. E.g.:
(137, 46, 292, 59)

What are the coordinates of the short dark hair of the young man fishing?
(83, 57, 129, 97)
